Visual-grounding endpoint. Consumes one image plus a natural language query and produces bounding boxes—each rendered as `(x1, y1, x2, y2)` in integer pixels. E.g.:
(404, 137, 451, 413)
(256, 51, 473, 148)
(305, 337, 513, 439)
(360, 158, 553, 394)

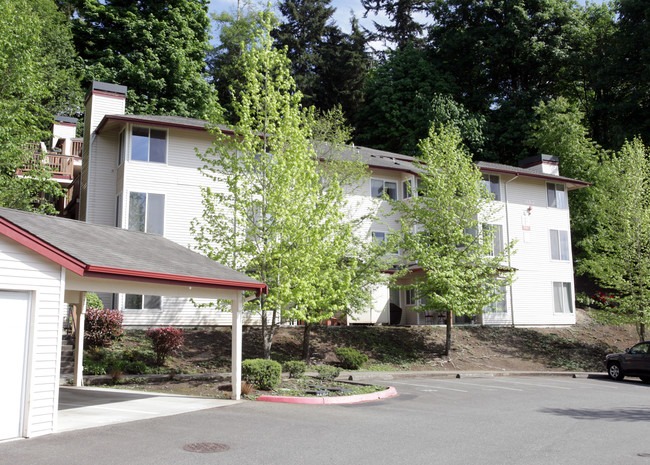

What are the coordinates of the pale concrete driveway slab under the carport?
(56, 387, 240, 432)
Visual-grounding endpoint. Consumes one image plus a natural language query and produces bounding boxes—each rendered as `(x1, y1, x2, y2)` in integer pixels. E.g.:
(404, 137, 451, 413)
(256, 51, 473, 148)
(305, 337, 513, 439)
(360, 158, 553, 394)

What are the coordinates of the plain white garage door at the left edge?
(0, 291, 31, 440)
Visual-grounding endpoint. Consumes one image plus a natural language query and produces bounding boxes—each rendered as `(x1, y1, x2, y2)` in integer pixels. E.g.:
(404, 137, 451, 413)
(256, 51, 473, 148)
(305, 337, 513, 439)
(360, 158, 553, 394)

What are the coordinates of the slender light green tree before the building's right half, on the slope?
(393, 125, 513, 355)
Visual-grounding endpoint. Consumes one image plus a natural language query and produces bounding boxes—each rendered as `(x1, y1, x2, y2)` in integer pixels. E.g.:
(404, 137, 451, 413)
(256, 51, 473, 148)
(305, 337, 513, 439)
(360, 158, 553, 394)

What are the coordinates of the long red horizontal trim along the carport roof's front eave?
(83, 265, 268, 295)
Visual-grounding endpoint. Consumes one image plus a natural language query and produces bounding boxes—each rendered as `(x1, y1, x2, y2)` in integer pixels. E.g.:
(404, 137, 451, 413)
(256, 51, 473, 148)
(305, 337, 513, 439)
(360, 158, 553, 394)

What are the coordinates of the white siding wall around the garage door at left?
(0, 237, 65, 437)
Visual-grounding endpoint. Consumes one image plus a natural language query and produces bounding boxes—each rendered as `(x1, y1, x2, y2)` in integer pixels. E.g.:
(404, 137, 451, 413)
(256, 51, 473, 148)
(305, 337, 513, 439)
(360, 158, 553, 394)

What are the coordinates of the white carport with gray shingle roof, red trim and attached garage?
(0, 208, 266, 441)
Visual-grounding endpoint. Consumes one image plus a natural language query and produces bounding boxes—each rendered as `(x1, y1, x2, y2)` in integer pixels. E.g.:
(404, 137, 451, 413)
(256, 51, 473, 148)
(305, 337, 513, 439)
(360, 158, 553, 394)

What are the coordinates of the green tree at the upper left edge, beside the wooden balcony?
(0, 0, 62, 213)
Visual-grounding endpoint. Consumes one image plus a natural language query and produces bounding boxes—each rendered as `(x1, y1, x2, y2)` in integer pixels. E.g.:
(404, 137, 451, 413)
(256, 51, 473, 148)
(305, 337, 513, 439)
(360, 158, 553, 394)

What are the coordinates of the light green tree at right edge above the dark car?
(578, 139, 650, 341)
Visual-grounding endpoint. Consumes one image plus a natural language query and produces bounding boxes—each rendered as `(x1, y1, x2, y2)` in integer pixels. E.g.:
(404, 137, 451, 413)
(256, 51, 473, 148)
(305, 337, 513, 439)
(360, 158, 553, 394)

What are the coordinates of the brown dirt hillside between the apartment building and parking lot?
(167, 310, 638, 372)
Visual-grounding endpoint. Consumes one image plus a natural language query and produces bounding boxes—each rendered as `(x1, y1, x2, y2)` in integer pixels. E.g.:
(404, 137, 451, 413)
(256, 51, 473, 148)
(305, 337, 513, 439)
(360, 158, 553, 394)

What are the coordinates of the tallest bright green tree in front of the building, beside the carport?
(193, 12, 380, 358)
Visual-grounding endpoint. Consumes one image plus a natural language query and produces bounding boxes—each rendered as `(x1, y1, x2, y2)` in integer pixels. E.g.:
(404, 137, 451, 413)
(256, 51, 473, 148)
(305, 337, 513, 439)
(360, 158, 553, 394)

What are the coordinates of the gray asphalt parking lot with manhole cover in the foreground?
(0, 376, 650, 465)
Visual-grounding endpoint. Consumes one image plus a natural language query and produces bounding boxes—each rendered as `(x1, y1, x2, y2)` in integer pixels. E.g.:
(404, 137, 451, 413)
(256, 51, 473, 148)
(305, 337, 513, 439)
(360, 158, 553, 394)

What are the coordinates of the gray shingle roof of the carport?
(0, 208, 264, 289)
